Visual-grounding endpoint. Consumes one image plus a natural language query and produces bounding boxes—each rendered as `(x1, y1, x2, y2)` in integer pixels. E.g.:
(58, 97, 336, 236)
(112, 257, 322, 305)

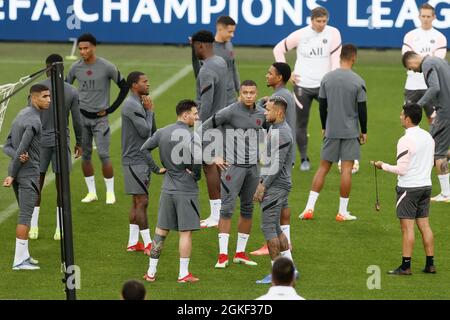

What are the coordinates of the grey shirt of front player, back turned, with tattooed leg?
(141, 121, 201, 195)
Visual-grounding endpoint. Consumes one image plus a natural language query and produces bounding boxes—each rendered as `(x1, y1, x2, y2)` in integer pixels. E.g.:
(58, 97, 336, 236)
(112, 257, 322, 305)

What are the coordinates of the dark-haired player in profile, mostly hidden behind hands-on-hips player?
(192, 30, 228, 228)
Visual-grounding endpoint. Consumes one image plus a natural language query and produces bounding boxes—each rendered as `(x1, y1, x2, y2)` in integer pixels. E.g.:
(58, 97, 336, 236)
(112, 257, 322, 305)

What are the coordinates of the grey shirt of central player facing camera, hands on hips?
(201, 102, 266, 166)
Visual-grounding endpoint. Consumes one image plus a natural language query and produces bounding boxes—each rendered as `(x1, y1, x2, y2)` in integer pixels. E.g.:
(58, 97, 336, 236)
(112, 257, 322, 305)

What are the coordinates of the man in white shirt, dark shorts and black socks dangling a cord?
(375, 104, 436, 275)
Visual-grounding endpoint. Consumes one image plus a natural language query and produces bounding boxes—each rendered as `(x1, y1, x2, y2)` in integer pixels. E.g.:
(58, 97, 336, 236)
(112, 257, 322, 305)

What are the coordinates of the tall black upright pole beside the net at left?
(51, 62, 78, 300)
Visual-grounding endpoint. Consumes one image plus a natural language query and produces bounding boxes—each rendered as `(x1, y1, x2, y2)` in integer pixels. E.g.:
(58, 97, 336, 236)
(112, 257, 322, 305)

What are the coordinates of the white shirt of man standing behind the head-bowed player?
(402, 28, 447, 90)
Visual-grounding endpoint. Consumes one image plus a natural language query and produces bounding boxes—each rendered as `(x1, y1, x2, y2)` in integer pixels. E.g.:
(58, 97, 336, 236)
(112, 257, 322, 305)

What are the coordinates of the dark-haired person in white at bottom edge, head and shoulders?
(256, 257, 305, 300)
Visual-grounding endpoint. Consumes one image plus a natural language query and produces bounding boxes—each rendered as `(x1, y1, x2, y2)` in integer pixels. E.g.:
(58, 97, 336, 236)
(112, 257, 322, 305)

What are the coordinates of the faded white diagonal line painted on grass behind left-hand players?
(0, 65, 192, 224)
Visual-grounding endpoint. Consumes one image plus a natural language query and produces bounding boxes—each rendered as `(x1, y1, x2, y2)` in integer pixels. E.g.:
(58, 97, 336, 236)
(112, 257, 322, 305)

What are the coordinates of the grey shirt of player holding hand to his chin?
(122, 94, 159, 173)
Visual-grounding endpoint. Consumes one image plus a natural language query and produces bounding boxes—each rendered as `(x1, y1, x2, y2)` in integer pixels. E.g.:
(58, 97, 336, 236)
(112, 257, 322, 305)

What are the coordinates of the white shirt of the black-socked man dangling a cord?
(383, 126, 434, 188)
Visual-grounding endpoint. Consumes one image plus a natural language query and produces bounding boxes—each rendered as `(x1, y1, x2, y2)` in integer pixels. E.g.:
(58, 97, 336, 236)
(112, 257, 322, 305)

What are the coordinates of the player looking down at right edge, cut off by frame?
(403, 51, 450, 203)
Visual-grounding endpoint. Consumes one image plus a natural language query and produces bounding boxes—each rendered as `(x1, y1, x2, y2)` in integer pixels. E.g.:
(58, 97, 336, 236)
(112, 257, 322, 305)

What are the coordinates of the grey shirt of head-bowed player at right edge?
(417, 56, 450, 119)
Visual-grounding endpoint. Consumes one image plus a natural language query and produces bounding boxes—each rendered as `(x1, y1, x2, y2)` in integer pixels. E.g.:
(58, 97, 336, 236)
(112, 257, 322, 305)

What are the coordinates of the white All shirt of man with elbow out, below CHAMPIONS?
(273, 25, 342, 88)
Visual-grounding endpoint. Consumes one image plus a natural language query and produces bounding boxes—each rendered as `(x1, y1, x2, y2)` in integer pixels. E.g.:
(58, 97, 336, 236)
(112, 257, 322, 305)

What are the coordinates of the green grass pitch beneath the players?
(0, 43, 450, 299)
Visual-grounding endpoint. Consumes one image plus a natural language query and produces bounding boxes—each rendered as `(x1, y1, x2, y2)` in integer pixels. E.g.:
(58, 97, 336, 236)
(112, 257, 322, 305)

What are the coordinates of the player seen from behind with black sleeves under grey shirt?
(300, 44, 367, 221)
